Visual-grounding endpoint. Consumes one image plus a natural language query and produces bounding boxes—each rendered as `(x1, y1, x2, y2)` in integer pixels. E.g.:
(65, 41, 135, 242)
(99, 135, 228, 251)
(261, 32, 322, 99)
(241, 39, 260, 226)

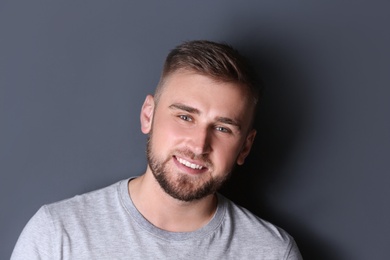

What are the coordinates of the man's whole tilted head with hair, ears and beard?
(141, 41, 257, 201)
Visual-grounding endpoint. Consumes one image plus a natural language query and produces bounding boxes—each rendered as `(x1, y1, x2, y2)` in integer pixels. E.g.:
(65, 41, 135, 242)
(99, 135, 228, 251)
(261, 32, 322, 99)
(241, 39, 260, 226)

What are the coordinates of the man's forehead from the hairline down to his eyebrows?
(158, 71, 254, 128)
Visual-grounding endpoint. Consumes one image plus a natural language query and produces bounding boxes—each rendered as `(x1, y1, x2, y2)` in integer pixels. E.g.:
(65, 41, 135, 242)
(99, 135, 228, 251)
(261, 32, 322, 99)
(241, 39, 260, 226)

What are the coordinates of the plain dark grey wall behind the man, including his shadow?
(0, 0, 390, 259)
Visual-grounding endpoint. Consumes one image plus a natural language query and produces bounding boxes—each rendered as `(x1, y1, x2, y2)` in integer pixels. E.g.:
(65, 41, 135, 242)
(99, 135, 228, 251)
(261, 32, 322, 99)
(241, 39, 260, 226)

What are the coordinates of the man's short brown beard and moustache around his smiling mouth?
(146, 132, 230, 202)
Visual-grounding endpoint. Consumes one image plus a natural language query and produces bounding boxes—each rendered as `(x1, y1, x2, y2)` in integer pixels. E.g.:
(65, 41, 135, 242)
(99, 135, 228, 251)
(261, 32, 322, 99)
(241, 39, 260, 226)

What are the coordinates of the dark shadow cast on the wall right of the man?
(221, 41, 341, 260)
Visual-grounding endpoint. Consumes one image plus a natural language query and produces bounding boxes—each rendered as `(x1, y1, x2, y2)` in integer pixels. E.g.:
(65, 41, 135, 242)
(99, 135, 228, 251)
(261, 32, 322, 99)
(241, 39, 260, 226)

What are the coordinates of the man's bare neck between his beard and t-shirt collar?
(129, 171, 217, 232)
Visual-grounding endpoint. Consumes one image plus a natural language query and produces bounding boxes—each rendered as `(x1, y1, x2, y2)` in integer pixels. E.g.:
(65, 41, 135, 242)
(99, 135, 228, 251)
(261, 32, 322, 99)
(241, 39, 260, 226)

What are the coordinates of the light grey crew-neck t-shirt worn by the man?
(11, 180, 302, 260)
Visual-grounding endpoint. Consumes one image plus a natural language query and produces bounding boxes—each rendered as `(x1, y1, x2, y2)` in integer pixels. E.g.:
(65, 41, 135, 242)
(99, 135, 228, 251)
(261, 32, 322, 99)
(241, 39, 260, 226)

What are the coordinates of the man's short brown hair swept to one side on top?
(155, 40, 259, 105)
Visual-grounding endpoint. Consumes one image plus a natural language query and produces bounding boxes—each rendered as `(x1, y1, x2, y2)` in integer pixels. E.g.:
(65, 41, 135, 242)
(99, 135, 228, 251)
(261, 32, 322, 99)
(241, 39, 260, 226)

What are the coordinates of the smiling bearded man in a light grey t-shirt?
(11, 41, 301, 259)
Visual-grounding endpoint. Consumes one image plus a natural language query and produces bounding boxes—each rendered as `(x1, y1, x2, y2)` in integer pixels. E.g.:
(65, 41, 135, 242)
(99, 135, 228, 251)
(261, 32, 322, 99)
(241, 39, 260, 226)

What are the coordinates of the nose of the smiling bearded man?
(189, 127, 211, 155)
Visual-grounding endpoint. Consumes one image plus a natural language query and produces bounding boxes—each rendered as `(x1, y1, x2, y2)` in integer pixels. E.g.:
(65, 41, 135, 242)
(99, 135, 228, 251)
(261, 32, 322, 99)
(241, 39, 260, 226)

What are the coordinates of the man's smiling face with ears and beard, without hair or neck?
(141, 71, 256, 201)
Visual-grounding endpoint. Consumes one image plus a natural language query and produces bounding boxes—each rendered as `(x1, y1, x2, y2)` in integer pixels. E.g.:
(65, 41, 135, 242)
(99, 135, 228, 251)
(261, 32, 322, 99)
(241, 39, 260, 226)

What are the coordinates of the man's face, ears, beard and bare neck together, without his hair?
(129, 71, 256, 231)
